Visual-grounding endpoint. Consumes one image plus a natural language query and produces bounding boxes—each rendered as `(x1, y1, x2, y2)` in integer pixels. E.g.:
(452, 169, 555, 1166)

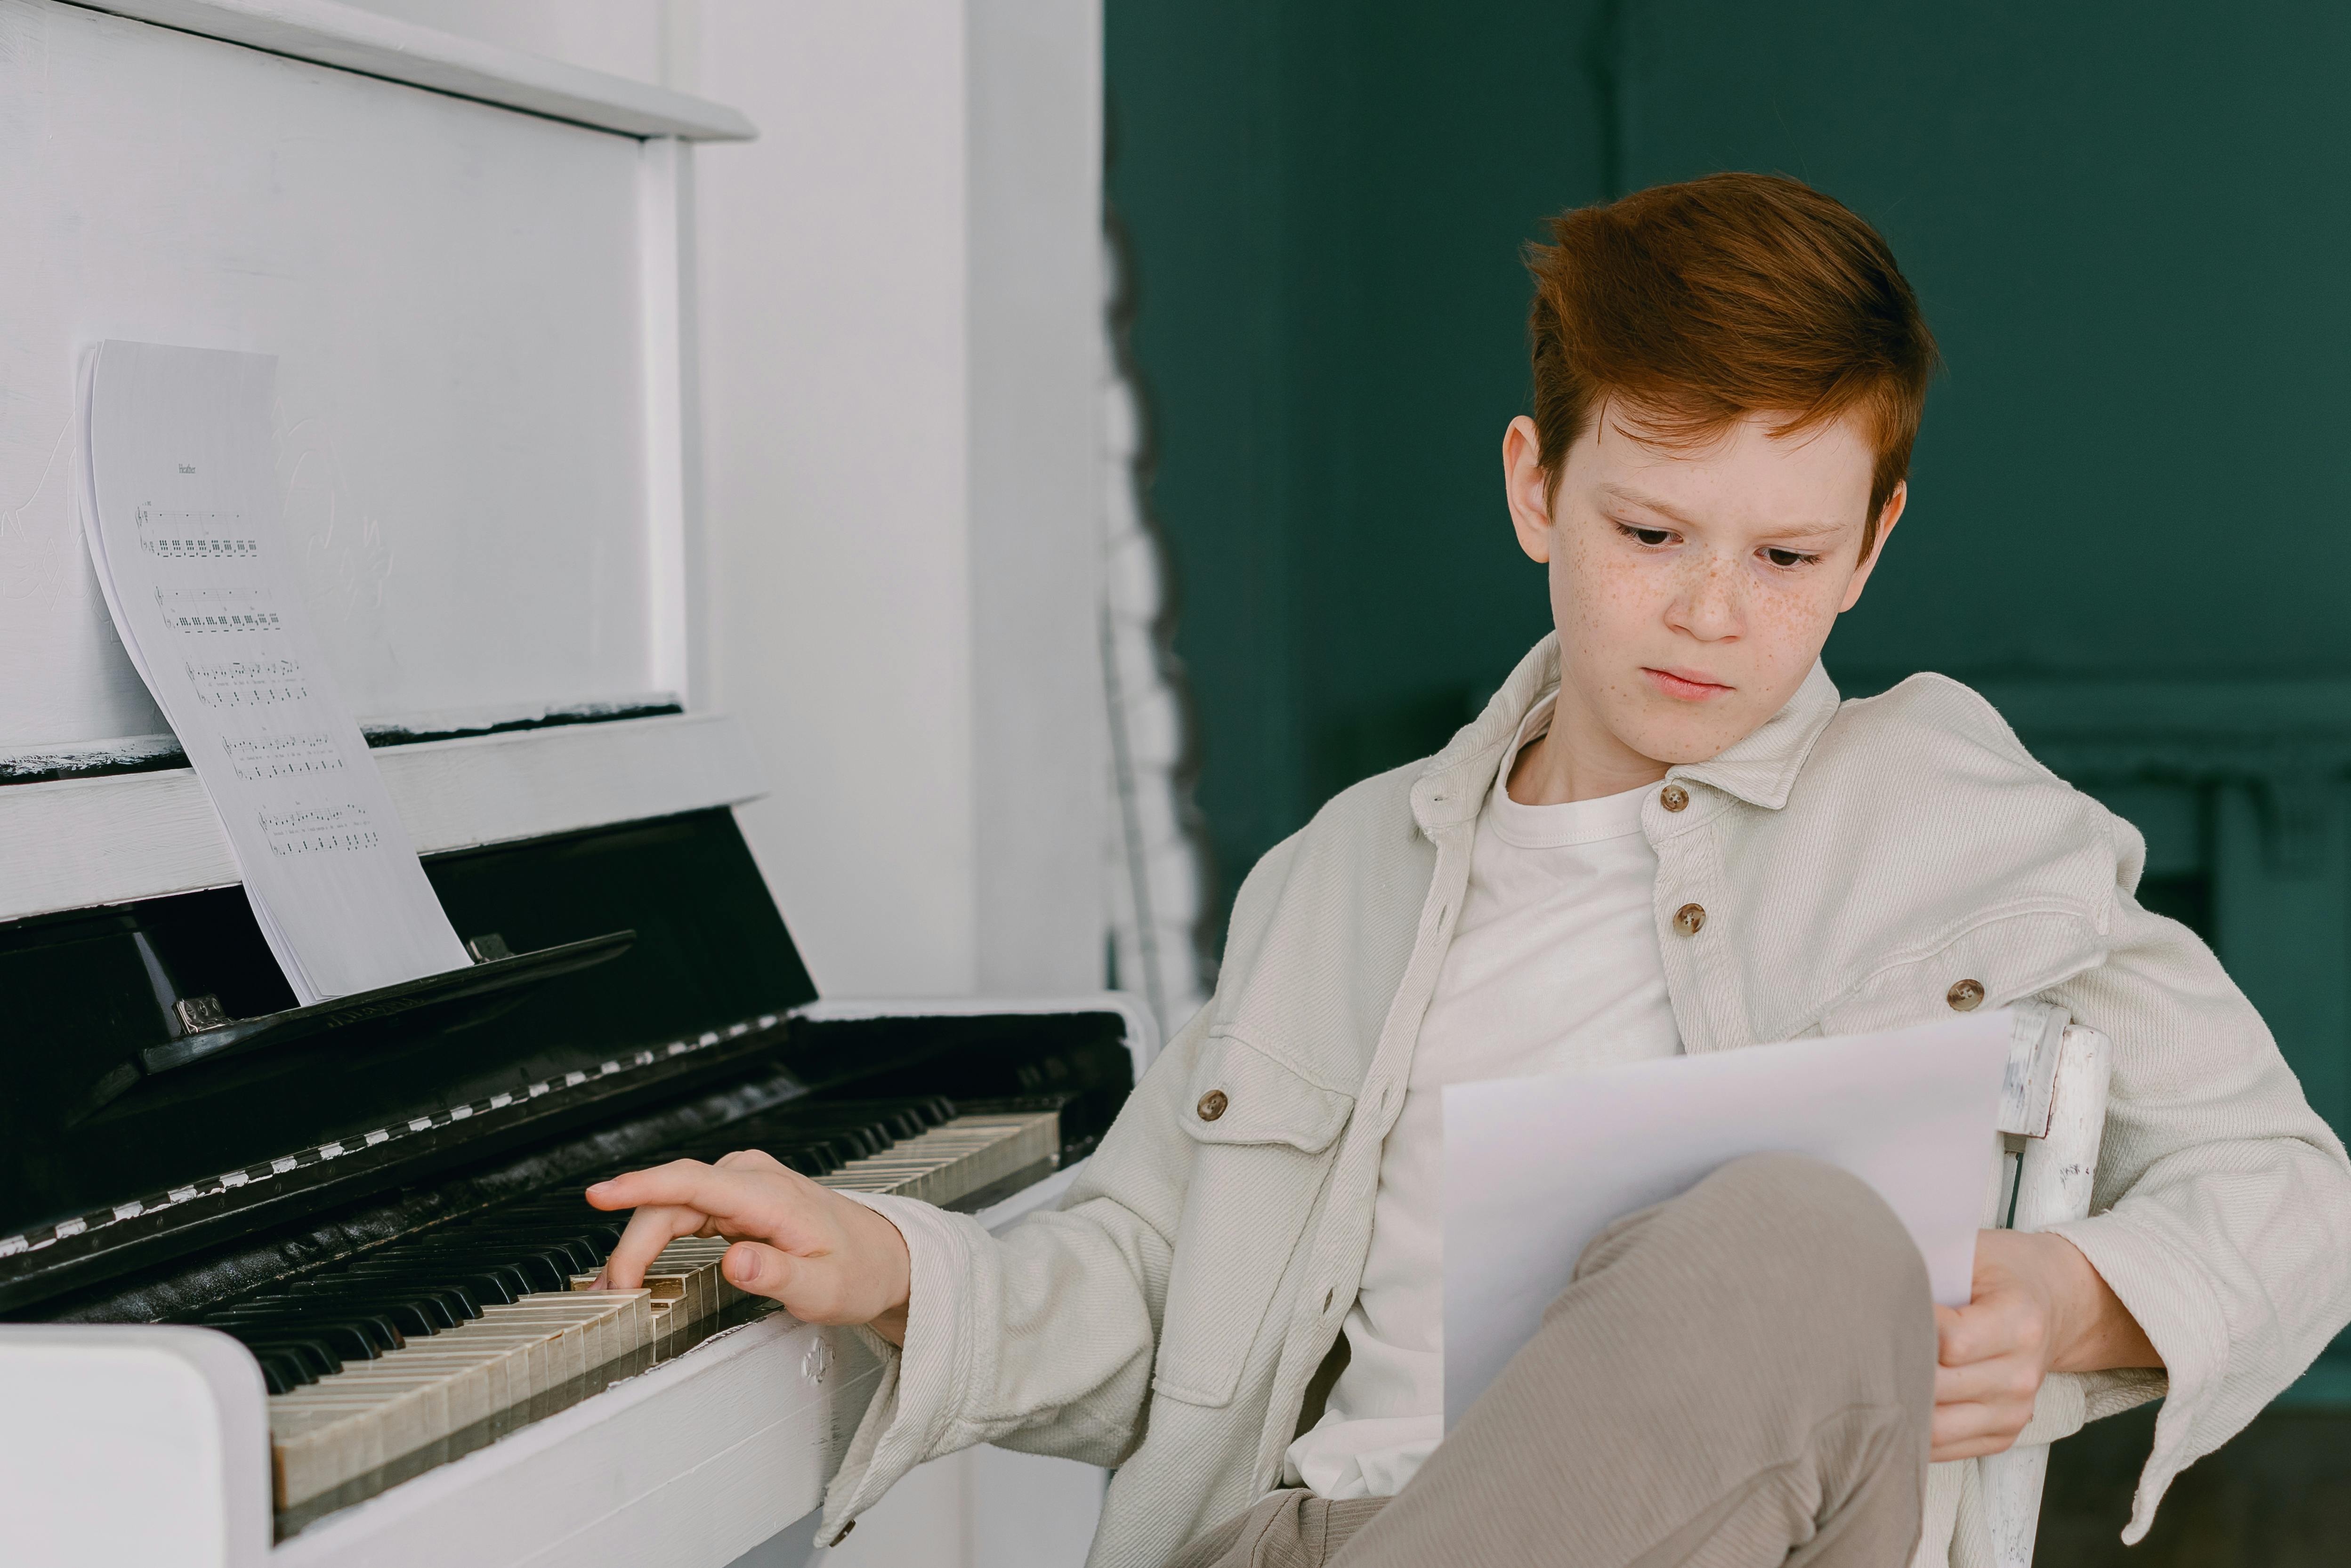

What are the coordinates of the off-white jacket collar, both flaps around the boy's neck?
(1413, 632, 1839, 835)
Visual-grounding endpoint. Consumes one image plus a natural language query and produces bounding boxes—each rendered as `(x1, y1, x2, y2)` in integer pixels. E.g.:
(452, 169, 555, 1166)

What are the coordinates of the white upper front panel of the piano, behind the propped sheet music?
(0, 0, 682, 750)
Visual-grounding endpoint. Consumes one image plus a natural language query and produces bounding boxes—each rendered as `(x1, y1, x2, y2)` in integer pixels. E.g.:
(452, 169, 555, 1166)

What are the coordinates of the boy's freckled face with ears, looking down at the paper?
(1503, 407, 1904, 771)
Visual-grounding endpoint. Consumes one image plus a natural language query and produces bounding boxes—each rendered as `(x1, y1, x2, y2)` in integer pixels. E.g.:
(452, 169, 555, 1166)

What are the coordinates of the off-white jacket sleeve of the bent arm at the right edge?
(2052, 879, 2351, 1542)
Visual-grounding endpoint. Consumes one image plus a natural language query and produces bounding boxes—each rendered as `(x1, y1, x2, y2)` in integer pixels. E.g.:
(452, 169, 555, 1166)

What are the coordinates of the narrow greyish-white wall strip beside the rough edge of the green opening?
(966, 0, 1110, 994)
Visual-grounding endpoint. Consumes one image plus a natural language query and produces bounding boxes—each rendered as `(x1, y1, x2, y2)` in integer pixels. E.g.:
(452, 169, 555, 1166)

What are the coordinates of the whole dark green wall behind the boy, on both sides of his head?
(1110, 0, 2351, 982)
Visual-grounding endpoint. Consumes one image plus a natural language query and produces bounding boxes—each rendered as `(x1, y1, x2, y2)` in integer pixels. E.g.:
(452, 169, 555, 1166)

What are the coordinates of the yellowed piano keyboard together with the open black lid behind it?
(0, 811, 1147, 1537)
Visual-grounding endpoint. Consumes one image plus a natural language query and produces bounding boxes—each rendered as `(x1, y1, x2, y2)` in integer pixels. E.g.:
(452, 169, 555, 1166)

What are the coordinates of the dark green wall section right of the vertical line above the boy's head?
(1620, 0, 2351, 677)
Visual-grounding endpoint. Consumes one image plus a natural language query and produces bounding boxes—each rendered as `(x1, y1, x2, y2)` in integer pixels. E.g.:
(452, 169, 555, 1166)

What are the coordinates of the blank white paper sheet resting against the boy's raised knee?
(1444, 1008, 2010, 1429)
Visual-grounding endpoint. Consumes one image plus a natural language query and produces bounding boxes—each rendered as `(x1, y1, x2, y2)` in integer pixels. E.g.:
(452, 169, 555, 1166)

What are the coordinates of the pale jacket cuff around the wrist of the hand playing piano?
(818, 1192, 987, 1544)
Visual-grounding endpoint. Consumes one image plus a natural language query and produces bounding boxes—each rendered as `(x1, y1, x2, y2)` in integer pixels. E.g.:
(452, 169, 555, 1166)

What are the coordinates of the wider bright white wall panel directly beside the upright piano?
(696, 0, 983, 997)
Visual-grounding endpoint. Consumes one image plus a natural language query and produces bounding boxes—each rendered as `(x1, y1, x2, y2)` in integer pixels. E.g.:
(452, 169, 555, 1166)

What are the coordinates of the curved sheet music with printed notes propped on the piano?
(75, 341, 468, 1004)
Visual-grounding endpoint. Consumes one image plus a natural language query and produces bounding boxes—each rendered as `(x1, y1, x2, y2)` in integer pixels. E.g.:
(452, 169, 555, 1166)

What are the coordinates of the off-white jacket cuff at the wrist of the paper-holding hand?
(2048, 1213, 2229, 1544)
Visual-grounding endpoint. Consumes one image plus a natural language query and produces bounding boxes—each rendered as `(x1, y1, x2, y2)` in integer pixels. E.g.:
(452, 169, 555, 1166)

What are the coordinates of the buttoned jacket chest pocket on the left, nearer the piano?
(1155, 1034, 1354, 1406)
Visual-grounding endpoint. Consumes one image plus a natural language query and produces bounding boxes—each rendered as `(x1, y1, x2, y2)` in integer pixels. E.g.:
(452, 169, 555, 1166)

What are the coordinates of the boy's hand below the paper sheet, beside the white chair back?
(1930, 1230, 2163, 1464)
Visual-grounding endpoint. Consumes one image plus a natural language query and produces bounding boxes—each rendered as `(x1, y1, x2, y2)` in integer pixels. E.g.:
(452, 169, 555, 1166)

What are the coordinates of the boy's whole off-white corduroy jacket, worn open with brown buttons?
(825, 639, 2351, 1568)
